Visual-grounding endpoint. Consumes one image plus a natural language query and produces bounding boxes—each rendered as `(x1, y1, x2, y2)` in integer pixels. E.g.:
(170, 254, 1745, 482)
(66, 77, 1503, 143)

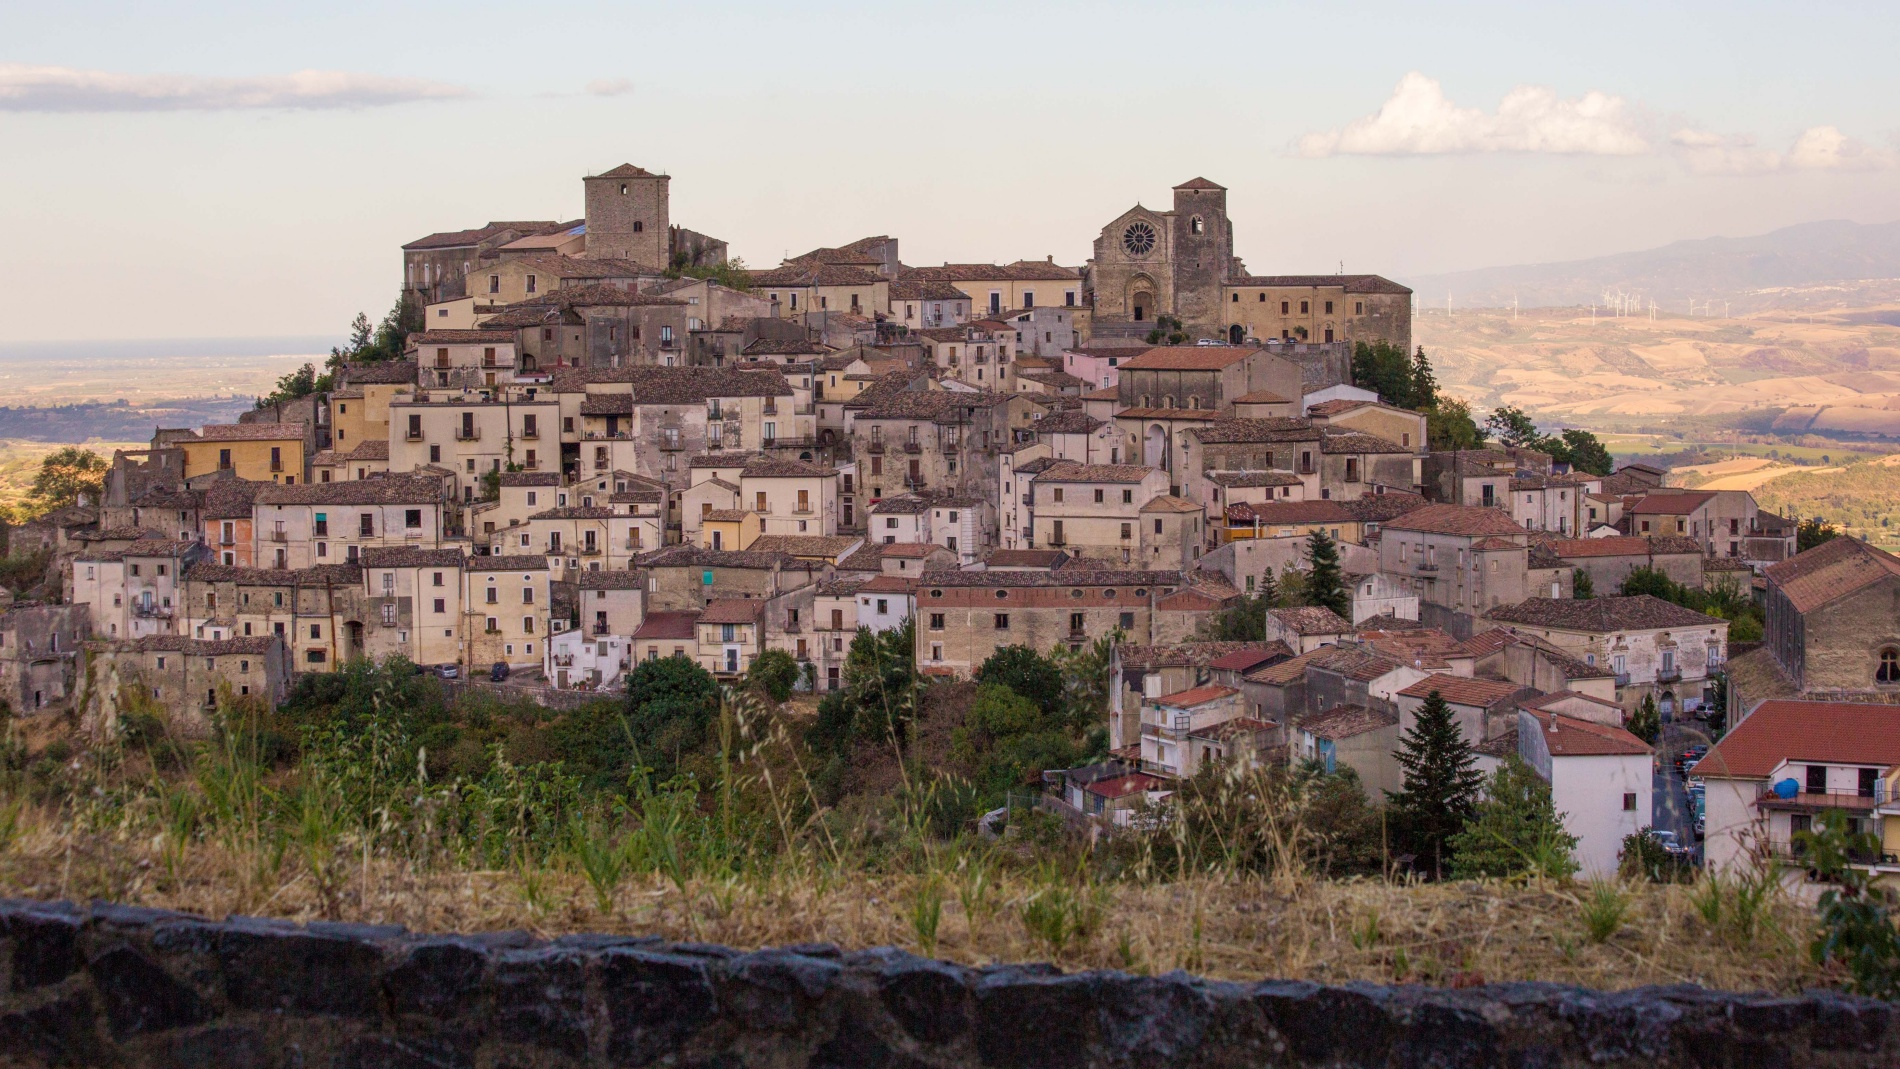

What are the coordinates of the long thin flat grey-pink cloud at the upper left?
(0, 63, 469, 112)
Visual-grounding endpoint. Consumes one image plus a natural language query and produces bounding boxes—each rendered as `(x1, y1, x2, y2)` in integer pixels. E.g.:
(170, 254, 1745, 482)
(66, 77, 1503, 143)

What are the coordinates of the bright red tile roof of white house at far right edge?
(1695, 699, 1900, 780)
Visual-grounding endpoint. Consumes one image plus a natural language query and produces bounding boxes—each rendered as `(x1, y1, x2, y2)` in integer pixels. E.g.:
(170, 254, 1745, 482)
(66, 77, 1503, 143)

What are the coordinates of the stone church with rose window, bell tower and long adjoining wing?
(1087, 178, 1412, 349)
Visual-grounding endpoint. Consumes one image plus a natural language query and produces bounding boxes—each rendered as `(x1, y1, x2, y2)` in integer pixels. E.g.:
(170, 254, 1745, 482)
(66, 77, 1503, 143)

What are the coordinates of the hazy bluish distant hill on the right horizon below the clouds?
(1400, 218, 1900, 313)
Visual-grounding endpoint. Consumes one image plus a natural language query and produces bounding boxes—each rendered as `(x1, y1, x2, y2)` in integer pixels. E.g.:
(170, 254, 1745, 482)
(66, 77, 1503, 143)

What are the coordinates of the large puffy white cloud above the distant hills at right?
(1300, 70, 1649, 158)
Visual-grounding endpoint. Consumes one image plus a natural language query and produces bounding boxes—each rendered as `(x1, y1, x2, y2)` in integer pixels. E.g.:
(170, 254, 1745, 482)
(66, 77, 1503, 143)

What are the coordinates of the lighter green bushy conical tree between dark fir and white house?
(1448, 756, 1577, 879)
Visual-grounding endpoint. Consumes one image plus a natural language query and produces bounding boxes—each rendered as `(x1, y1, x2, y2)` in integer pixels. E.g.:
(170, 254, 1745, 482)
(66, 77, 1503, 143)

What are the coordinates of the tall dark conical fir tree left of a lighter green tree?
(1387, 691, 1484, 873)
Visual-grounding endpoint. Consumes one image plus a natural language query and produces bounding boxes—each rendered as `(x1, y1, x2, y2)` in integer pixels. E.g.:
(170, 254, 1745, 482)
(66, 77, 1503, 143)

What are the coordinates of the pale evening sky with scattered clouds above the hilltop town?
(0, 0, 1900, 344)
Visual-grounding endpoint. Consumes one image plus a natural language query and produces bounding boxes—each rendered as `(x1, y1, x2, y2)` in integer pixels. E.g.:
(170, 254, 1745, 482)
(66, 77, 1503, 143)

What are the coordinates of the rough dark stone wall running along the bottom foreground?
(0, 900, 1900, 1069)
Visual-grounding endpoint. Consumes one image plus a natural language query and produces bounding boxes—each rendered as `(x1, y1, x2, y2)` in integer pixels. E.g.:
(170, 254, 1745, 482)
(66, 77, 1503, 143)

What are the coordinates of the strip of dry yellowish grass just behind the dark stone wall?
(0, 811, 1820, 991)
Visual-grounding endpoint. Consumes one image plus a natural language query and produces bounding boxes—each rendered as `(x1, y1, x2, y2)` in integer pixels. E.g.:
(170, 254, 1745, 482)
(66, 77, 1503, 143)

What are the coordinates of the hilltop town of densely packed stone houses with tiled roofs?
(0, 165, 1900, 892)
